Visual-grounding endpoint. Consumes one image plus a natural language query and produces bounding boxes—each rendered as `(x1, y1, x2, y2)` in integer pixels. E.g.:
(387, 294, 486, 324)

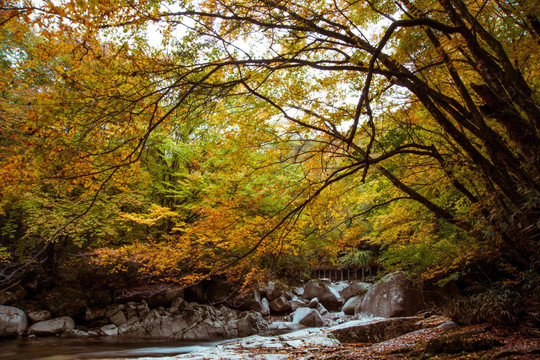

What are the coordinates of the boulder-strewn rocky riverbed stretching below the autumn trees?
(0, 272, 540, 360)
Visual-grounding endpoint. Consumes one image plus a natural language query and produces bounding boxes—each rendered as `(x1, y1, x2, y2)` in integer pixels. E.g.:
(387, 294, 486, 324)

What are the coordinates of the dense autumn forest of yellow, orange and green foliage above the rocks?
(0, 0, 540, 320)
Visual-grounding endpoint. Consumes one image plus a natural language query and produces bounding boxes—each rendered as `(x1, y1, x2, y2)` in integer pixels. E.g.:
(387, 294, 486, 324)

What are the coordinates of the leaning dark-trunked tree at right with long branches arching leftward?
(2, 0, 540, 286)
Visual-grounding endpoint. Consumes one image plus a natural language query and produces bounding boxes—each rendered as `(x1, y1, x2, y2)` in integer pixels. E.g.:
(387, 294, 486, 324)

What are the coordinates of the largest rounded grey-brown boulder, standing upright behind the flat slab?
(357, 271, 422, 318)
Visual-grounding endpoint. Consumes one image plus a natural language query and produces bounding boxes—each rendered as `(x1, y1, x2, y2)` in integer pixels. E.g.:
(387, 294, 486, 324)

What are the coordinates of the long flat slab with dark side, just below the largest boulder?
(328, 317, 422, 343)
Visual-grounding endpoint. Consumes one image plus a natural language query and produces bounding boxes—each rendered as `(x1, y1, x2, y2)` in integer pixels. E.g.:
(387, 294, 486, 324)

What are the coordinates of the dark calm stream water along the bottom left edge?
(0, 336, 230, 360)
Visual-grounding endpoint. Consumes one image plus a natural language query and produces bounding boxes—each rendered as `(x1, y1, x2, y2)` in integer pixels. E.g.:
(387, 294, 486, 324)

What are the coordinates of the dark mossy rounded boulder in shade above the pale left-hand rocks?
(41, 288, 88, 317)
